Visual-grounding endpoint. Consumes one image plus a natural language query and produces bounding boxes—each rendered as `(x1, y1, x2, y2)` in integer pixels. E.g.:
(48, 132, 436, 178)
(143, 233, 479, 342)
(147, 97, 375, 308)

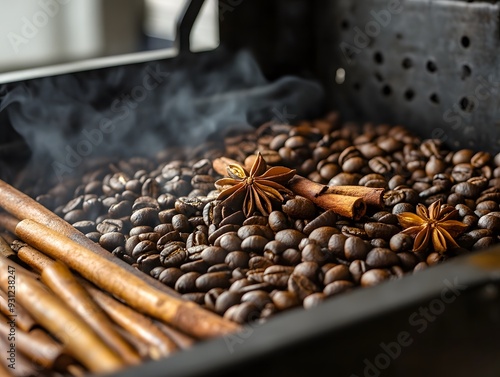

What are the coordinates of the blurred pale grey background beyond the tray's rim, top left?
(0, 0, 219, 73)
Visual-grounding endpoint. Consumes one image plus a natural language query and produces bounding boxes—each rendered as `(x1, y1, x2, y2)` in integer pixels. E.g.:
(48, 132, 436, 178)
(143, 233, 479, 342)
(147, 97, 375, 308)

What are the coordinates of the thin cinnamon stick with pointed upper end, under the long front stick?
(86, 284, 177, 359)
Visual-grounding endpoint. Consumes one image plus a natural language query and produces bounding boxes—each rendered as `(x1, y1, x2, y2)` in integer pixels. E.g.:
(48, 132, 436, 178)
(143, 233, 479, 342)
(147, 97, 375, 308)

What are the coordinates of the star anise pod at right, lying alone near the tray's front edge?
(397, 200, 467, 253)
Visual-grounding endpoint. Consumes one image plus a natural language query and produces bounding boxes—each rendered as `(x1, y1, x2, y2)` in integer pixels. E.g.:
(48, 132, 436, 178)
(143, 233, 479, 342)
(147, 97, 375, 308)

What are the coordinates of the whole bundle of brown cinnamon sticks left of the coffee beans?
(0, 181, 239, 376)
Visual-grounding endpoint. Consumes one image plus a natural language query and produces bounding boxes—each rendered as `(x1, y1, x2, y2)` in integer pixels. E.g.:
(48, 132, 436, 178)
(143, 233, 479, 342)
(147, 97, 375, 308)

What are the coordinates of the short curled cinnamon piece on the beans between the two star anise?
(288, 175, 366, 220)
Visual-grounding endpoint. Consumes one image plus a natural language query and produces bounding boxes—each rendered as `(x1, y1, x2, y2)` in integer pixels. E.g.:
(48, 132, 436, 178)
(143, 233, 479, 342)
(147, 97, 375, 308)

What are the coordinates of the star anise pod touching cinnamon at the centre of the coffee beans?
(215, 153, 295, 217)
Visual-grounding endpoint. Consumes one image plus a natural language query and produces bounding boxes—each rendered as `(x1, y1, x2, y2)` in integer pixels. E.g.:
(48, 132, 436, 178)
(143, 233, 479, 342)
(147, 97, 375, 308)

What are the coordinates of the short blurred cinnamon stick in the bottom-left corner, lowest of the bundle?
(0, 315, 72, 368)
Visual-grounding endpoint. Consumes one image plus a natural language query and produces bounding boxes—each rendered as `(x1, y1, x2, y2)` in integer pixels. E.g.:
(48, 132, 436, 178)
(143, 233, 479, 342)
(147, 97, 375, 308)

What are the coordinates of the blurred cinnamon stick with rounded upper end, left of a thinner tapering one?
(41, 262, 141, 365)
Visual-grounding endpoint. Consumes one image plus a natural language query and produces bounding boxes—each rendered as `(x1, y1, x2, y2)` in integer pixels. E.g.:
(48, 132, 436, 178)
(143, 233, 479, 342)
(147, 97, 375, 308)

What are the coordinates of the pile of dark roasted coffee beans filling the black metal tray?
(31, 114, 500, 323)
